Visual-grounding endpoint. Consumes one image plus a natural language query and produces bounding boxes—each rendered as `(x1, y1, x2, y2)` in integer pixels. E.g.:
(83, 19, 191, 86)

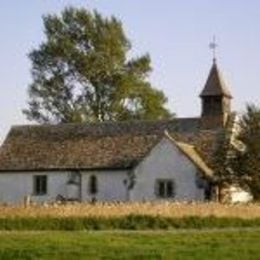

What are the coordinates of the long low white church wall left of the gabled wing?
(0, 171, 128, 203)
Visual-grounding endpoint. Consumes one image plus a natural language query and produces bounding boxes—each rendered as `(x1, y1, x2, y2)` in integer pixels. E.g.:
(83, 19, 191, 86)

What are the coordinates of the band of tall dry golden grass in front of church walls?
(0, 202, 260, 219)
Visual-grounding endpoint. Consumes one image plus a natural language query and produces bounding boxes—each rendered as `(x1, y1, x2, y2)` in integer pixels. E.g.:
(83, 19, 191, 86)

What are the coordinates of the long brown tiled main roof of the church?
(0, 118, 219, 171)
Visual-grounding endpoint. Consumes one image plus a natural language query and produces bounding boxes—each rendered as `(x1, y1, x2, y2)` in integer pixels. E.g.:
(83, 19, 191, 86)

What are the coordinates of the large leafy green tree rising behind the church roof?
(23, 7, 171, 123)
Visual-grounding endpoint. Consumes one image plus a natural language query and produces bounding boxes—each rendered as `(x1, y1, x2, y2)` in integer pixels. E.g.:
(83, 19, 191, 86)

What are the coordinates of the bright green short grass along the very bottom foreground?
(0, 229, 260, 260)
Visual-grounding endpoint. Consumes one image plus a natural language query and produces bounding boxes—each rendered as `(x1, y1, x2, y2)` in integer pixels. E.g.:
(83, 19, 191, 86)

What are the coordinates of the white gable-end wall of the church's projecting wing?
(130, 138, 205, 201)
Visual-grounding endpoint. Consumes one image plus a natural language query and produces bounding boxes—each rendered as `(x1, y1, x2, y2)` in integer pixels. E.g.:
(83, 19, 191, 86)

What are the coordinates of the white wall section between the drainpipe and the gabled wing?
(81, 170, 128, 201)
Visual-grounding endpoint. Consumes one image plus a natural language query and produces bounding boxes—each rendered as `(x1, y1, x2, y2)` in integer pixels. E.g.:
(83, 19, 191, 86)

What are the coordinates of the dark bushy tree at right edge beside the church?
(234, 104, 260, 200)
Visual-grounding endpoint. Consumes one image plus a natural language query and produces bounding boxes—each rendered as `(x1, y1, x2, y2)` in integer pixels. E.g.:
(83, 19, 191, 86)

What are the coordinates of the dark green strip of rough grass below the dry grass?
(0, 215, 260, 231)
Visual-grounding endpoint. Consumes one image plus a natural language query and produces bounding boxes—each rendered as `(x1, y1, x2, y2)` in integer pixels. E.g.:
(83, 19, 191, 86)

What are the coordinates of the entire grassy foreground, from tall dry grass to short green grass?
(0, 202, 260, 260)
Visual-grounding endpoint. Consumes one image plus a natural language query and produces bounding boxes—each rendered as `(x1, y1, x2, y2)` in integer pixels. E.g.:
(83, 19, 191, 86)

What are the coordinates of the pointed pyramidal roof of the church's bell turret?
(200, 62, 232, 98)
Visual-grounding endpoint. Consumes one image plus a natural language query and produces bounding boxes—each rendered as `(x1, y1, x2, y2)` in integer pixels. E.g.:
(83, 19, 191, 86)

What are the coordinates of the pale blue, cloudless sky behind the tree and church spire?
(0, 0, 260, 143)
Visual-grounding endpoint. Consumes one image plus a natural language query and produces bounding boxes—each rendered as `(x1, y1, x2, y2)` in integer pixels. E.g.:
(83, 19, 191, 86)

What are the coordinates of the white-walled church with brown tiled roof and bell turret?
(0, 59, 248, 203)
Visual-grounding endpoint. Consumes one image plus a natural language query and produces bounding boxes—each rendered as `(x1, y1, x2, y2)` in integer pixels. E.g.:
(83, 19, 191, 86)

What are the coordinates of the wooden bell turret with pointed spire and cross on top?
(200, 39, 232, 129)
